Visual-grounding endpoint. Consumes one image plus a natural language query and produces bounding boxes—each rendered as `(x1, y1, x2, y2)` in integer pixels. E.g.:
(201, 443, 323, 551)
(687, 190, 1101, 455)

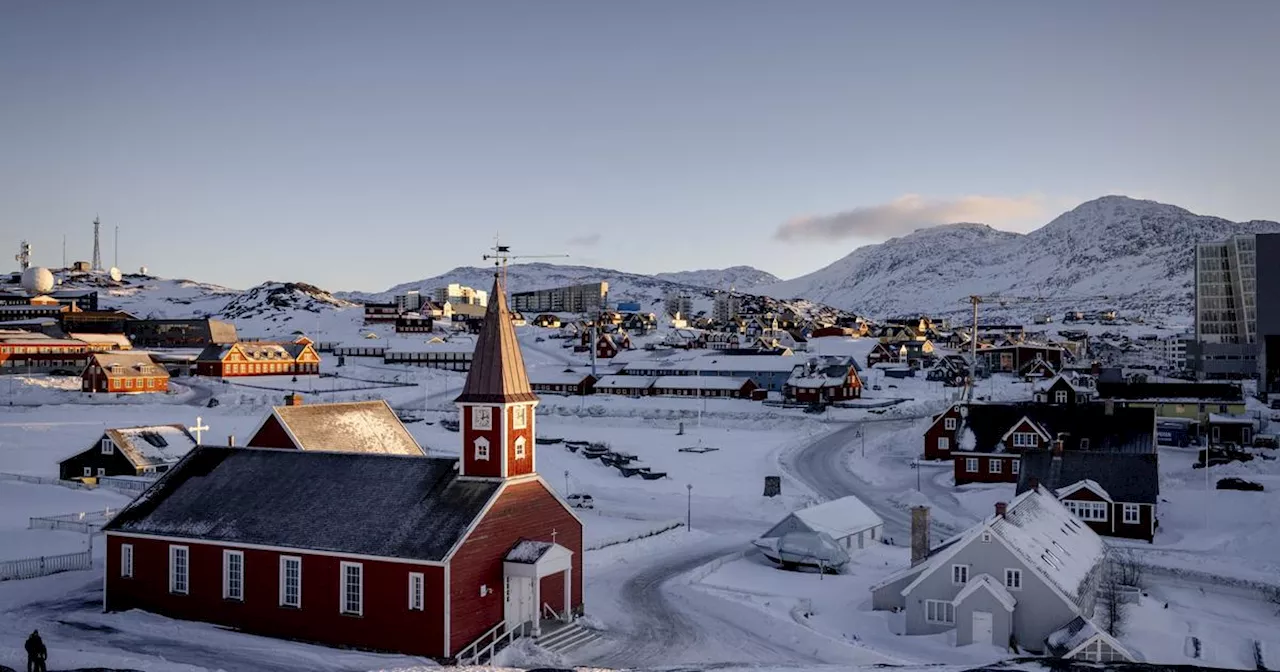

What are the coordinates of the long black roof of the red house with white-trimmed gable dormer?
(959, 403, 1156, 453)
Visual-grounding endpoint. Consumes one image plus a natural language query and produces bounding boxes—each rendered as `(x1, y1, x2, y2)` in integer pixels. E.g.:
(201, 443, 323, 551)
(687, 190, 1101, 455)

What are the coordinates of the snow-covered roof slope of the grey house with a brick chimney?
(989, 488, 1106, 600)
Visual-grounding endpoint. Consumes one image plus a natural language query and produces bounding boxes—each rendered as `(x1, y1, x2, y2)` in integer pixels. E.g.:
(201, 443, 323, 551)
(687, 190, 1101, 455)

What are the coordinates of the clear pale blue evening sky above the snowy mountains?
(0, 0, 1280, 291)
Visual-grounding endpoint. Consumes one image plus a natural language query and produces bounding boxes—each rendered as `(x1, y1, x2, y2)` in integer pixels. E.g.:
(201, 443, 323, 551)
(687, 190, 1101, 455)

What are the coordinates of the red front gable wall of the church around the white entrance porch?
(449, 480, 582, 653)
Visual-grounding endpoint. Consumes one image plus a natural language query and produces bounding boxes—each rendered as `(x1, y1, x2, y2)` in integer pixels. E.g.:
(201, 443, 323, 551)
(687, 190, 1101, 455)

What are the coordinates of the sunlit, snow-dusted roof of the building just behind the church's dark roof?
(273, 401, 426, 456)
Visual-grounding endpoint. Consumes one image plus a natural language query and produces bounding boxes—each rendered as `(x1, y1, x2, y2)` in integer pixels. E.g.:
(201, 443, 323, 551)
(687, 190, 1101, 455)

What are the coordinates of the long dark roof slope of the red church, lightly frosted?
(104, 445, 500, 561)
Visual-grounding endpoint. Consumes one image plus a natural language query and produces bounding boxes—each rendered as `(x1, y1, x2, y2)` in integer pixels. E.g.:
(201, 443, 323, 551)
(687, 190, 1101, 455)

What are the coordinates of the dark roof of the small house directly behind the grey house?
(1018, 451, 1160, 504)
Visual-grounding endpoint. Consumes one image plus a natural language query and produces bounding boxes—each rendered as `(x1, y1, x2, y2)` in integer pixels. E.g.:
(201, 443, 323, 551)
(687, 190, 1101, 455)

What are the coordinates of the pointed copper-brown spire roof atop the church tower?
(454, 275, 538, 403)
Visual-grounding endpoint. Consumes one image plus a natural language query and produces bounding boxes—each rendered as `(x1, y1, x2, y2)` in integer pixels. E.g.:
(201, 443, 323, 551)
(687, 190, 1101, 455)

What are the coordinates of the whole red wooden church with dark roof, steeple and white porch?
(104, 278, 582, 659)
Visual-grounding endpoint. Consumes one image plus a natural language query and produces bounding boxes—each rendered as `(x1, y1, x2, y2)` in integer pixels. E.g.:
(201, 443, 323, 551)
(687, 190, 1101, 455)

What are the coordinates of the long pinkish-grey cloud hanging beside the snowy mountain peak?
(773, 193, 1044, 241)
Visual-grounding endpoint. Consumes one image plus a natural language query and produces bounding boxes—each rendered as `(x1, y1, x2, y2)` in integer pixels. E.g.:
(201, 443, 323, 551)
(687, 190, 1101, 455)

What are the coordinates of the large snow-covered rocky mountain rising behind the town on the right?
(755, 196, 1280, 320)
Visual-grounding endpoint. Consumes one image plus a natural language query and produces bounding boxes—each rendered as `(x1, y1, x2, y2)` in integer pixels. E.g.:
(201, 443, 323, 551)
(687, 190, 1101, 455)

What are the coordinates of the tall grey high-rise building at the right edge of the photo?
(1187, 233, 1280, 383)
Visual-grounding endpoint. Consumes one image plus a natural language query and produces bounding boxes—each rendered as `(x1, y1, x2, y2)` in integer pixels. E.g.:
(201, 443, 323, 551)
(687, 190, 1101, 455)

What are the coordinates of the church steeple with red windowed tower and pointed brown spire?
(454, 274, 538, 479)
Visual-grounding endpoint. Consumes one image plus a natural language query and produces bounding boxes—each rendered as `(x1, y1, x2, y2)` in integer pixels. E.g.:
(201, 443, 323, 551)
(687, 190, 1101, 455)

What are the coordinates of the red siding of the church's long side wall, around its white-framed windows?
(106, 535, 444, 657)
